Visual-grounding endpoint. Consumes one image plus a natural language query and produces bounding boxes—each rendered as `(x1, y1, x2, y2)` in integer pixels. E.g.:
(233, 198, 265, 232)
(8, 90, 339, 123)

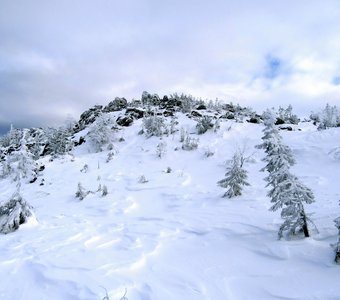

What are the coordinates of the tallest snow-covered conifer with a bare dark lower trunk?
(258, 110, 314, 238)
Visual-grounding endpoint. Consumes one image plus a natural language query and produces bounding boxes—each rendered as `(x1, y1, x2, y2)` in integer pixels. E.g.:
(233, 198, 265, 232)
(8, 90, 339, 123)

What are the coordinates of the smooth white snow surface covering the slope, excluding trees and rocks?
(0, 121, 340, 300)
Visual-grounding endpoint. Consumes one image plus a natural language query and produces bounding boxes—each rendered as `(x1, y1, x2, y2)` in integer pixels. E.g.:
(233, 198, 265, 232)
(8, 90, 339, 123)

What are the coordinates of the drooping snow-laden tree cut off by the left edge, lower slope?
(0, 191, 34, 234)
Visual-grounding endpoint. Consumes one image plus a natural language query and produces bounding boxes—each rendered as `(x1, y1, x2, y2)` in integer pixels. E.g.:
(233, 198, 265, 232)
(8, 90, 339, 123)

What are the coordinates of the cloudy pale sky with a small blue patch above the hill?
(0, 0, 340, 132)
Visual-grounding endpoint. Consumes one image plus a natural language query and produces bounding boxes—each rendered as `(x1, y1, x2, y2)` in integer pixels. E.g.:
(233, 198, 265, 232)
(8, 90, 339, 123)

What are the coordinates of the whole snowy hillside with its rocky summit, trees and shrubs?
(0, 92, 340, 300)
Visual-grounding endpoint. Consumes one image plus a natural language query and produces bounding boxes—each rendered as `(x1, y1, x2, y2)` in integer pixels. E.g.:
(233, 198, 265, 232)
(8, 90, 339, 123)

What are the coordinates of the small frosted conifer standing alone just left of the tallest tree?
(217, 152, 249, 198)
